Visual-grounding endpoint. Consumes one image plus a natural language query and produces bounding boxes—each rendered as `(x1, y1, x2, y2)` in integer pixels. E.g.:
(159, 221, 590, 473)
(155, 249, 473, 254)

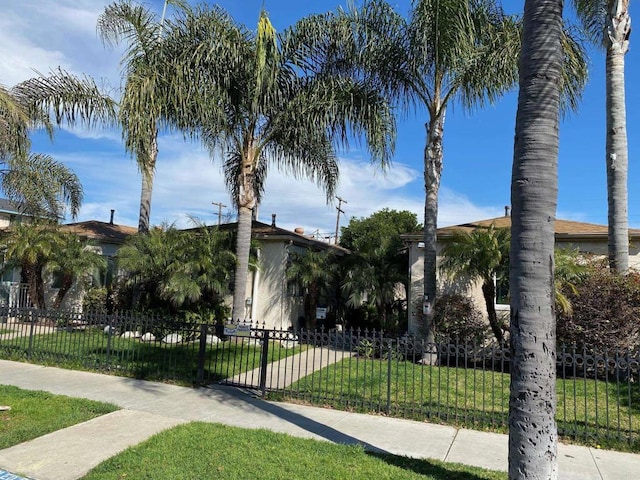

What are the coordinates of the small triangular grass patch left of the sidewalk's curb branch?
(0, 385, 118, 449)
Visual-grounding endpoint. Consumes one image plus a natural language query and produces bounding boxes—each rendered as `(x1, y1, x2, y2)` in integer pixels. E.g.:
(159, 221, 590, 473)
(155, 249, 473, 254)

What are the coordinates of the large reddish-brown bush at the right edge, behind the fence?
(557, 268, 640, 350)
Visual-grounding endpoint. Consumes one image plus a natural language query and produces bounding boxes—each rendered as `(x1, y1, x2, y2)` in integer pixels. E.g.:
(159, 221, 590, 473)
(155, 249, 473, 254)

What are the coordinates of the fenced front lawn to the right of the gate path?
(278, 357, 640, 451)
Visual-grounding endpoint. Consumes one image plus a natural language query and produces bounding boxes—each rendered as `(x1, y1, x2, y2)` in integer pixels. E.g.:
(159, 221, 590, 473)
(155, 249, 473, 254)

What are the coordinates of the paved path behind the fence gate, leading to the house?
(223, 347, 354, 390)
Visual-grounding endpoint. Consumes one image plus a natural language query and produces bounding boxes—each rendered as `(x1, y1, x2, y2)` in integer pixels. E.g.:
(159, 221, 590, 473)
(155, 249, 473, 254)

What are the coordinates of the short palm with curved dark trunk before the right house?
(441, 225, 509, 344)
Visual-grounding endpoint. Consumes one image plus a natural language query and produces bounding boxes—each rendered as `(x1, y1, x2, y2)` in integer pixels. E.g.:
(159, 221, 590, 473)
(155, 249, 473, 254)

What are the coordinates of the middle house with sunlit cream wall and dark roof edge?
(215, 215, 347, 330)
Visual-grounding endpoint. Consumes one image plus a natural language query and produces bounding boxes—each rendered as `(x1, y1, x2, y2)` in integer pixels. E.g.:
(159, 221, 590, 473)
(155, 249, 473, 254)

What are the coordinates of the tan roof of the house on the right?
(403, 216, 640, 241)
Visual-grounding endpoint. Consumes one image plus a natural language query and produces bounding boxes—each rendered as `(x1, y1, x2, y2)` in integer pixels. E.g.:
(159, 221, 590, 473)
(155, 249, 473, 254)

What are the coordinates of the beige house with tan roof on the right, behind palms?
(402, 215, 640, 333)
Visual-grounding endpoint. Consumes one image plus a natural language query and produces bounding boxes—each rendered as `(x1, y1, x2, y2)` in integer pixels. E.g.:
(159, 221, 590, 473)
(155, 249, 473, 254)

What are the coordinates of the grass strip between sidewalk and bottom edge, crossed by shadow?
(83, 422, 507, 480)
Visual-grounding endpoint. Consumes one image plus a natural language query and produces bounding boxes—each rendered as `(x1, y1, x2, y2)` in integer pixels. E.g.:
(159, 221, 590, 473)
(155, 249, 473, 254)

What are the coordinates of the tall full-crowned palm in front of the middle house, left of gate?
(163, 6, 395, 321)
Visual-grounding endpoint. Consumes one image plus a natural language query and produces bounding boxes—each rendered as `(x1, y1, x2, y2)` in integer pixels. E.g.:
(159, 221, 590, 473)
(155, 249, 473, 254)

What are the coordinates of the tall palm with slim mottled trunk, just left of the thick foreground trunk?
(336, 0, 586, 352)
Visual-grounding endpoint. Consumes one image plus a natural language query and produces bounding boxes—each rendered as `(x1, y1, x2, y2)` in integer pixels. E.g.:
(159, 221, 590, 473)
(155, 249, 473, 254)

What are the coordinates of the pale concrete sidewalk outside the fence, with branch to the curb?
(0, 360, 640, 480)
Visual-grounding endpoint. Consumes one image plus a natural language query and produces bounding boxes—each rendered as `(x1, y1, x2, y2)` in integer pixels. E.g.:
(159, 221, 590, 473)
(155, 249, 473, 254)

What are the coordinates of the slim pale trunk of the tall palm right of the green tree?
(422, 108, 444, 364)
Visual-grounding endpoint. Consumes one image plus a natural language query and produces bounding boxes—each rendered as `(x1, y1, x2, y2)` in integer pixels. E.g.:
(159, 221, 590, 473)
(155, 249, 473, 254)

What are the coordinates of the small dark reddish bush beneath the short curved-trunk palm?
(434, 294, 489, 343)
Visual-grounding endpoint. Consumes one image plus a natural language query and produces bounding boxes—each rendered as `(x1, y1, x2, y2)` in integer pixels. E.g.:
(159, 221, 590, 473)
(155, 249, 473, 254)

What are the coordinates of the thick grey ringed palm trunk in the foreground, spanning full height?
(509, 0, 563, 480)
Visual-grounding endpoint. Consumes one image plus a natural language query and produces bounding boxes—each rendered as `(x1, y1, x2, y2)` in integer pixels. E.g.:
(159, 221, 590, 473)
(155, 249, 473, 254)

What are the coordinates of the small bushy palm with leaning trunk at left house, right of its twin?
(46, 232, 107, 308)
